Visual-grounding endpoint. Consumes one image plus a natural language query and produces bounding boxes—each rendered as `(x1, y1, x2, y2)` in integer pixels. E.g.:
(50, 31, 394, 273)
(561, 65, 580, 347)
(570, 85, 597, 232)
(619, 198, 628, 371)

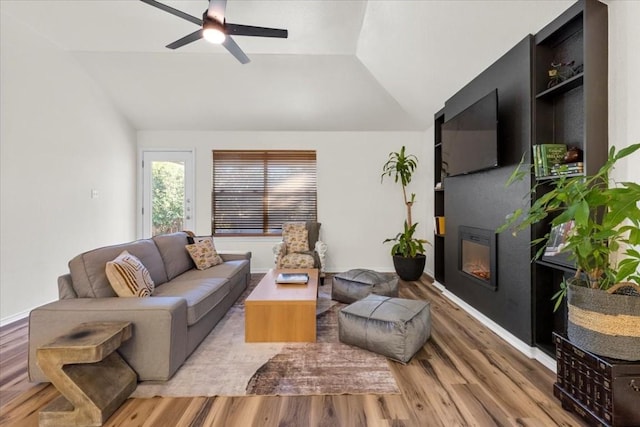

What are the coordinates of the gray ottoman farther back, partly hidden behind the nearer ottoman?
(331, 268, 398, 304)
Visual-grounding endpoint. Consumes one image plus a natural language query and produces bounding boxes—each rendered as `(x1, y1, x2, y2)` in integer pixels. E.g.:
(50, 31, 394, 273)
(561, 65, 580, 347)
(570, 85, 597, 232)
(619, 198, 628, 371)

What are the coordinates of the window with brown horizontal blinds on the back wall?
(211, 150, 317, 235)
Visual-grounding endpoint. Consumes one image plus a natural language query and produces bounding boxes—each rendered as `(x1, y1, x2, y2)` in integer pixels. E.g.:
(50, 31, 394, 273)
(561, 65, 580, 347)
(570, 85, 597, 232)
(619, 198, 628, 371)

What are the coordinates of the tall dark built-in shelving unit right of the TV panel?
(532, 0, 608, 356)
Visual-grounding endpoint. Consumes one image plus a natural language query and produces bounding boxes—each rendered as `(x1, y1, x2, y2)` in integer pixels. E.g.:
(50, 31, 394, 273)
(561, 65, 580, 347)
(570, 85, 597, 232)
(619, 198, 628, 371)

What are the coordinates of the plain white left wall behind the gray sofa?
(0, 14, 136, 324)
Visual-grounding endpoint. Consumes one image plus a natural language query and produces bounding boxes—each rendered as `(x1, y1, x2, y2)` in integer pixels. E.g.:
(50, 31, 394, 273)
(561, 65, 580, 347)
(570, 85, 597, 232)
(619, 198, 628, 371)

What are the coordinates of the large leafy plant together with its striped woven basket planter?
(497, 144, 640, 360)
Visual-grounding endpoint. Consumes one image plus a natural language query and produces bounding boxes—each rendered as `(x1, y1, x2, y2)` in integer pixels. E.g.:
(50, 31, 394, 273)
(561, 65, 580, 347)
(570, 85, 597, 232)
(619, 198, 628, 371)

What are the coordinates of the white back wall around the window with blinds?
(138, 131, 433, 272)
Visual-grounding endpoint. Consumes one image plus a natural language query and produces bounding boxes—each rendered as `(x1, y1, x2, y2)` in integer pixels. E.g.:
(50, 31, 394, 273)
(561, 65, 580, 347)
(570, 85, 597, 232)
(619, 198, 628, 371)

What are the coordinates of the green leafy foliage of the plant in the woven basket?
(497, 144, 640, 307)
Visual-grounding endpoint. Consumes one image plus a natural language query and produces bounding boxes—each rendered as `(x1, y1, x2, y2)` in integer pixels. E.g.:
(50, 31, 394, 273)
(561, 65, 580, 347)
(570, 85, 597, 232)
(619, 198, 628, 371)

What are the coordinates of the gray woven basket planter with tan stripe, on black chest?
(567, 285, 640, 361)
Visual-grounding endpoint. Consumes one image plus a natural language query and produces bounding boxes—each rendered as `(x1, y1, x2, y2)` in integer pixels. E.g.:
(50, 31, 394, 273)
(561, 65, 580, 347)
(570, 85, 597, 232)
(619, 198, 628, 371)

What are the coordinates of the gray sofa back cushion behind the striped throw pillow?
(69, 239, 168, 298)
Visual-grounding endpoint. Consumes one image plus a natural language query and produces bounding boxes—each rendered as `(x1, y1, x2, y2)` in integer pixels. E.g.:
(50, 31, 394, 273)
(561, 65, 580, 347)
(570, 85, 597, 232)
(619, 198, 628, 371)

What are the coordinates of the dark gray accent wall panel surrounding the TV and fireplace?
(444, 36, 533, 344)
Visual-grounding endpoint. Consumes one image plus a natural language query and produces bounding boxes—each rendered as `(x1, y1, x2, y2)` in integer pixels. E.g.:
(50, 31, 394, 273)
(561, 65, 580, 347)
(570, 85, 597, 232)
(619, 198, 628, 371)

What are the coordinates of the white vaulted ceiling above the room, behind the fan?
(0, 0, 573, 131)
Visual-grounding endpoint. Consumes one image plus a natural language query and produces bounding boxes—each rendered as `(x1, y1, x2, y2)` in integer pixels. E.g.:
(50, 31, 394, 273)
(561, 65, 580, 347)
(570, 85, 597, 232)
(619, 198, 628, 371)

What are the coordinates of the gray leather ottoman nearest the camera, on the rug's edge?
(338, 294, 431, 363)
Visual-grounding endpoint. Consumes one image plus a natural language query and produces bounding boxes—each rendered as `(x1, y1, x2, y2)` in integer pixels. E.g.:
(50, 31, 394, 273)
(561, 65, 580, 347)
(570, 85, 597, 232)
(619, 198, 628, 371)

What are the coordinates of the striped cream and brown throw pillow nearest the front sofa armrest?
(105, 251, 155, 297)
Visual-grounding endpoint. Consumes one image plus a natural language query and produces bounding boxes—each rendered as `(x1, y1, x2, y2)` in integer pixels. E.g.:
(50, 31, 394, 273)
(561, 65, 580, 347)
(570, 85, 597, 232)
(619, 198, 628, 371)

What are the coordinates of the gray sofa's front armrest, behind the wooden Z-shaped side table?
(29, 297, 187, 382)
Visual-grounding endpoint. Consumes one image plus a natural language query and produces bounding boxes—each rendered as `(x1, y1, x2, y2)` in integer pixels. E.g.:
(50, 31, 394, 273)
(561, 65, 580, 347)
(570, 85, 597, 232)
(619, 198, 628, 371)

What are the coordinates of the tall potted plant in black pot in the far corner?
(380, 146, 429, 281)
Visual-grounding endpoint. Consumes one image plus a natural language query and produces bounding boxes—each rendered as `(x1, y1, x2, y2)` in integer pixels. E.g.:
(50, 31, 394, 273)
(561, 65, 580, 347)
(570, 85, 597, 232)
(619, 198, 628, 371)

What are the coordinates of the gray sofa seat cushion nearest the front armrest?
(154, 278, 230, 326)
